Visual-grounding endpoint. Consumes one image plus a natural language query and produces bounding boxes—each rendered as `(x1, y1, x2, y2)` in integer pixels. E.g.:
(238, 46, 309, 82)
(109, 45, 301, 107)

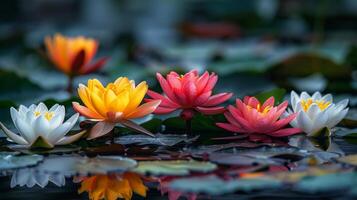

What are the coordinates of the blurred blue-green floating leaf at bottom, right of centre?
(169, 175, 283, 195)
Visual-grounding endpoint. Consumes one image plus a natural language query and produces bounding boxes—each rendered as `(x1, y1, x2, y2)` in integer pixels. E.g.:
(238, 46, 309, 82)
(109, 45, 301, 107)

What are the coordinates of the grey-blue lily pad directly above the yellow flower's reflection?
(38, 156, 137, 176)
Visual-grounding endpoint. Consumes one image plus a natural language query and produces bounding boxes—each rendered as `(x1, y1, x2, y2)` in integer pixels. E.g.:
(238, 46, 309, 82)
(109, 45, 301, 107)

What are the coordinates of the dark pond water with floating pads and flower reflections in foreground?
(0, 130, 357, 200)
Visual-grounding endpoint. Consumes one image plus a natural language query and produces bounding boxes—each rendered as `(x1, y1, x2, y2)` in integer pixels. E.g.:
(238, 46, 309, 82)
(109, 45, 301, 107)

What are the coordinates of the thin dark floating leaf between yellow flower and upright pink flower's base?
(115, 133, 199, 146)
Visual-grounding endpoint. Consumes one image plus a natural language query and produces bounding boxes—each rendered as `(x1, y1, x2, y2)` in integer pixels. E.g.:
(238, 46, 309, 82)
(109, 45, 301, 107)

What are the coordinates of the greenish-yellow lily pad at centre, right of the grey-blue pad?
(133, 160, 217, 176)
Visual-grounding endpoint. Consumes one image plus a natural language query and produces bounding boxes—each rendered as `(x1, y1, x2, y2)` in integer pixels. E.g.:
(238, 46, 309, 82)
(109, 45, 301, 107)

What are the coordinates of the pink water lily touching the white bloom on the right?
(217, 96, 301, 139)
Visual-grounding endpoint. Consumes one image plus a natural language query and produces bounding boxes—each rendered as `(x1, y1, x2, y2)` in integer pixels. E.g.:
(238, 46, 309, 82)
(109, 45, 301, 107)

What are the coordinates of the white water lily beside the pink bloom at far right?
(286, 91, 348, 136)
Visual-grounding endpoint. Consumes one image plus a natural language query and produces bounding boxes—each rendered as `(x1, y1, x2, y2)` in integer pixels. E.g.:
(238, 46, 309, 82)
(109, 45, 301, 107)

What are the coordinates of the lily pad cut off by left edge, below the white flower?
(0, 152, 43, 170)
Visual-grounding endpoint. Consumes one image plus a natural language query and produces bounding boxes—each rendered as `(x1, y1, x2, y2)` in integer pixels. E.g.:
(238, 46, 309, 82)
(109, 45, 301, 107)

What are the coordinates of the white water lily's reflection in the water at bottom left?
(10, 168, 66, 188)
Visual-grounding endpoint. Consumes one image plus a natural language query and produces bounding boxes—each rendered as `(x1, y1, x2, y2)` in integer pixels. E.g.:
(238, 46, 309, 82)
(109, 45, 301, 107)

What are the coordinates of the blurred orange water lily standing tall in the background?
(45, 34, 107, 89)
